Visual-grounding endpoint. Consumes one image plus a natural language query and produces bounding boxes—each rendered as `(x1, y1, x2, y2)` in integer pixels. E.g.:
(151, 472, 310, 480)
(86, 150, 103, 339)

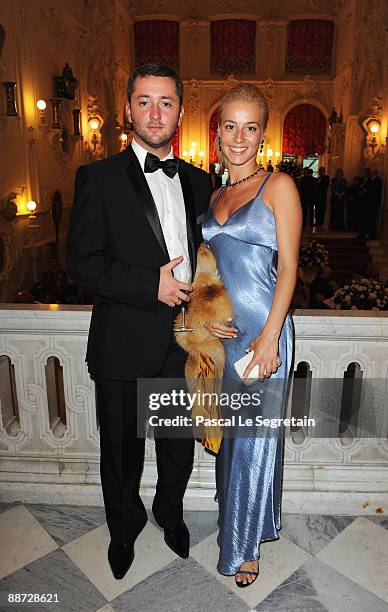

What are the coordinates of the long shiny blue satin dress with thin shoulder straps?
(203, 174, 293, 575)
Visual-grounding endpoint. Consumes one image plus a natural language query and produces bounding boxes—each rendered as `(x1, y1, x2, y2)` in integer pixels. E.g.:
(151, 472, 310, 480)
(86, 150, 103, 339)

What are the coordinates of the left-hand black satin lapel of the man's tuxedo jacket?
(127, 147, 170, 261)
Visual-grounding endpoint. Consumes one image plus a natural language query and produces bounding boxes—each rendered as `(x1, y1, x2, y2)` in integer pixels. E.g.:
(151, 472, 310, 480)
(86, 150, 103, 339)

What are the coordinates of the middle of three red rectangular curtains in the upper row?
(210, 19, 256, 74)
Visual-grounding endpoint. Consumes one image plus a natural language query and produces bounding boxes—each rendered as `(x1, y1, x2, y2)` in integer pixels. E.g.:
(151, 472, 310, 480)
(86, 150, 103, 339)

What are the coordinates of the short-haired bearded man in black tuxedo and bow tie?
(67, 64, 211, 579)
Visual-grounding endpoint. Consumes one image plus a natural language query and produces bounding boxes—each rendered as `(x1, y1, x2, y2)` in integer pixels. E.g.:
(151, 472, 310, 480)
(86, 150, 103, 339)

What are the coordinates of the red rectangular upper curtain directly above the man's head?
(134, 20, 179, 70)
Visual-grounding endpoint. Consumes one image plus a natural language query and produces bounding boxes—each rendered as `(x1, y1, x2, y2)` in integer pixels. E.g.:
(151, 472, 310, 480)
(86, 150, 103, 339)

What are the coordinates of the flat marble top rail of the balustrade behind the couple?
(0, 304, 388, 342)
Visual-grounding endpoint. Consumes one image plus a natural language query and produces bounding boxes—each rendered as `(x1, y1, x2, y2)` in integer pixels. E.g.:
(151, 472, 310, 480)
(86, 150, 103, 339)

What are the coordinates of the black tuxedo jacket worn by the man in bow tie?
(67, 146, 211, 380)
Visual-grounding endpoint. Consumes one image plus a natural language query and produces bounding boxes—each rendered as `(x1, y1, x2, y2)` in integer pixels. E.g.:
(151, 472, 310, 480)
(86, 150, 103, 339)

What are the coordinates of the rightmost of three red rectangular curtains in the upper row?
(286, 19, 334, 74)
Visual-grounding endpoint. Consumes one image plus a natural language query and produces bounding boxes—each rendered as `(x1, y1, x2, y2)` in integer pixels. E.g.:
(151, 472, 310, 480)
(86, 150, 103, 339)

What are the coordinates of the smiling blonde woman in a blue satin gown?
(203, 84, 302, 587)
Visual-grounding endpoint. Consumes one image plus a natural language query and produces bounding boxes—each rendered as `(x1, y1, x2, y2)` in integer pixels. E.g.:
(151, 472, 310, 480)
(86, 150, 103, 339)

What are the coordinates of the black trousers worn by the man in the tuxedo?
(95, 335, 194, 543)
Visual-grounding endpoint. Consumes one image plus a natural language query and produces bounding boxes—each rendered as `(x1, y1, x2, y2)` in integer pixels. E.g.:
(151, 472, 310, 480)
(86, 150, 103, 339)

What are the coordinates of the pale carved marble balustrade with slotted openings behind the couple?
(0, 304, 388, 515)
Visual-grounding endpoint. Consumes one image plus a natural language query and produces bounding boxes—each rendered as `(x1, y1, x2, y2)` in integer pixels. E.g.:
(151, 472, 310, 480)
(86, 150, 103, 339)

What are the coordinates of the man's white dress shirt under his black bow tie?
(131, 138, 191, 282)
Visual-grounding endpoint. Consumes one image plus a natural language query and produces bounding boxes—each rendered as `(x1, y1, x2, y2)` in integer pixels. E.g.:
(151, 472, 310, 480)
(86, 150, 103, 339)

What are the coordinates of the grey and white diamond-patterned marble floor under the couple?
(0, 504, 388, 612)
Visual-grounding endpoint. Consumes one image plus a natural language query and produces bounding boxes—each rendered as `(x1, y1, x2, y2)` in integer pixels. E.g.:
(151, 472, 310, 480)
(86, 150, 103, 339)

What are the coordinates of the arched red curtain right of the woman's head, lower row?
(283, 104, 326, 156)
